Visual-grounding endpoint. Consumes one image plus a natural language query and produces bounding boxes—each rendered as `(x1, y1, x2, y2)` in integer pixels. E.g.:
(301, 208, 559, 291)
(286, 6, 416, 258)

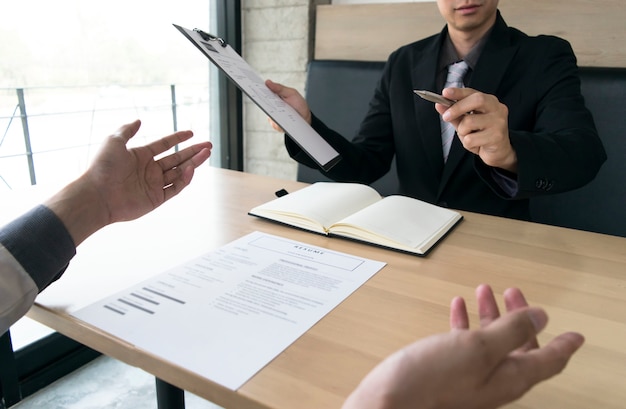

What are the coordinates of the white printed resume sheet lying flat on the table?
(73, 232, 385, 389)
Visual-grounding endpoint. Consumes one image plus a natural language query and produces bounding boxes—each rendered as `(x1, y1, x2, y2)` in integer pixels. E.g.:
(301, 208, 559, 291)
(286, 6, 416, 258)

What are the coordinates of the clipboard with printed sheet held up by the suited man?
(173, 24, 341, 171)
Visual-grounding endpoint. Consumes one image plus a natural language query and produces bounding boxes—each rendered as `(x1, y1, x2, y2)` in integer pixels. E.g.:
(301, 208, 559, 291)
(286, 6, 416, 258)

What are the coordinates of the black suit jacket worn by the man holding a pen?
(285, 12, 606, 219)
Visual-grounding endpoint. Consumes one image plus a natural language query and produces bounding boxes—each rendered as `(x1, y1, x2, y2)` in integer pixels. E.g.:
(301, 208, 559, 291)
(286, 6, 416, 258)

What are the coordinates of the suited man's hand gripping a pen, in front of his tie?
(435, 88, 517, 173)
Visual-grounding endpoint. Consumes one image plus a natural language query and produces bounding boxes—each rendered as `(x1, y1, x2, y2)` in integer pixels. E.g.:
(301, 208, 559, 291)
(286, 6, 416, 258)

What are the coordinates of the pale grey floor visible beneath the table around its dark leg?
(12, 356, 220, 409)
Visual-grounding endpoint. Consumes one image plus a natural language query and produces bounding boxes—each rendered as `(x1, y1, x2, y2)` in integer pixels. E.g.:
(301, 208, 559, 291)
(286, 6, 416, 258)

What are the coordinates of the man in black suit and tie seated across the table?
(267, 0, 606, 219)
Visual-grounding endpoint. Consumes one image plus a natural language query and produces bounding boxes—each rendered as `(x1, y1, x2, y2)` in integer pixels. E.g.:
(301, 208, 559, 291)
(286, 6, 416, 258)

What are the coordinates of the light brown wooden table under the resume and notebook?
(7, 166, 626, 409)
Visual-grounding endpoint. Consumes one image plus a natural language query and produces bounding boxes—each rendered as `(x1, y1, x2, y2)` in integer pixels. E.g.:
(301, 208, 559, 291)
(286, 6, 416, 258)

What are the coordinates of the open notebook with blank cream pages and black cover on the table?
(249, 182, 463, 256)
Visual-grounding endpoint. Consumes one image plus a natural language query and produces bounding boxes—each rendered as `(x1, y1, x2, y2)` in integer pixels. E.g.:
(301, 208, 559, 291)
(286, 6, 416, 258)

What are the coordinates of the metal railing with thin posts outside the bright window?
(0, 84, 210, 191)
